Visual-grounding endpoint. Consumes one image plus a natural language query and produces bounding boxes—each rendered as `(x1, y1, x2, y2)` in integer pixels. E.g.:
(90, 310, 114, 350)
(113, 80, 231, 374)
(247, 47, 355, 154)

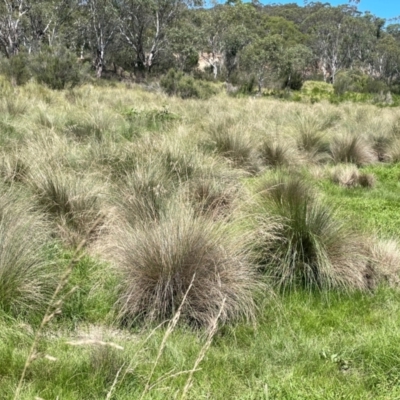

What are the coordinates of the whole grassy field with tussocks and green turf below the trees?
(0, 79, 400, 400)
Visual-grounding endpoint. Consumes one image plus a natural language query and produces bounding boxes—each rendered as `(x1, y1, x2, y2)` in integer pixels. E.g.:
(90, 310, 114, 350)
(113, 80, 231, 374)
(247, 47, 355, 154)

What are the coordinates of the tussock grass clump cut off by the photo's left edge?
(0, 189, 55, 315)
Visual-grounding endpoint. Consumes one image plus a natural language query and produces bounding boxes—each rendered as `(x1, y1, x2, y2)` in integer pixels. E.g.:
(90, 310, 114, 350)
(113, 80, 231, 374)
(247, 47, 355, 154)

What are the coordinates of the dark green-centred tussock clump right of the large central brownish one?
(258, 175, 368, 289)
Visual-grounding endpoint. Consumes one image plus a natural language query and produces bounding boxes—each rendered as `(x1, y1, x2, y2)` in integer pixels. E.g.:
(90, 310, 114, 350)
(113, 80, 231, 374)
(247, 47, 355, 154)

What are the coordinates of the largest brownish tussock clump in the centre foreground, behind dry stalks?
(103, 204, 260, 326)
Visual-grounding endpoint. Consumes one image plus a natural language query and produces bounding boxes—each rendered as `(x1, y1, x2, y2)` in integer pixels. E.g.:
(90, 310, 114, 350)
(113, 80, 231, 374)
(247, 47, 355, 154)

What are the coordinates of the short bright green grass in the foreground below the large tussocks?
(0, 288, 400, 399)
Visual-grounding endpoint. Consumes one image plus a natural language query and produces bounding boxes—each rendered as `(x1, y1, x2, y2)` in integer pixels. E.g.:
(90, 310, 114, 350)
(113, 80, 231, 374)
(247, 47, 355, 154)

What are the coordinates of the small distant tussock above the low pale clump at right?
(331, 134, 377, 167)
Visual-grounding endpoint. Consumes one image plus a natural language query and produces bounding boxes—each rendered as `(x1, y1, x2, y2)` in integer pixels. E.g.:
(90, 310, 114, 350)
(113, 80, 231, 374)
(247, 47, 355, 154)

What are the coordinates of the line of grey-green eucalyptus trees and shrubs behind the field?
(0, 0, 400, 93)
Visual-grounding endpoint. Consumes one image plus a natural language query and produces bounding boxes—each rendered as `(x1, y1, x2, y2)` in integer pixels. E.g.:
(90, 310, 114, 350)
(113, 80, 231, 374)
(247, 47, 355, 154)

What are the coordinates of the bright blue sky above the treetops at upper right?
(260, 0, 400, 22)
